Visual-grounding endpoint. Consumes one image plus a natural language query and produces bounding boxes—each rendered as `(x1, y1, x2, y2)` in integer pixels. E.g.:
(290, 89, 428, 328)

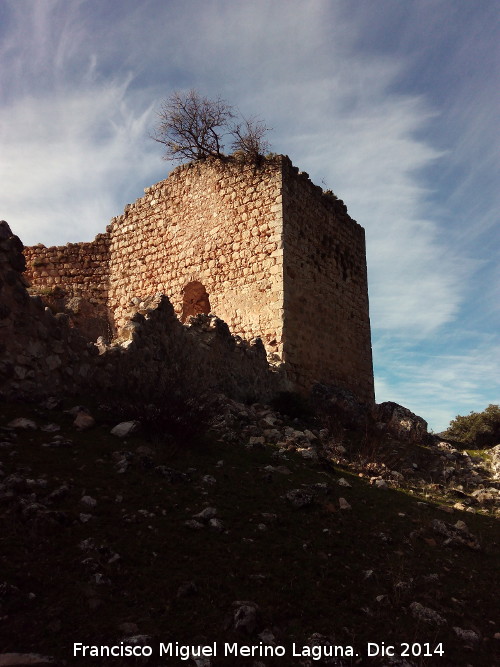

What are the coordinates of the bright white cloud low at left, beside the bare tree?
(0, 81, 156, 244)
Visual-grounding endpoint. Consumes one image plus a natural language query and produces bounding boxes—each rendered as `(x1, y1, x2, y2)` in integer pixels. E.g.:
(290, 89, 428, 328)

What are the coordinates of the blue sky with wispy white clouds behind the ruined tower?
(0, 0, 500, 431)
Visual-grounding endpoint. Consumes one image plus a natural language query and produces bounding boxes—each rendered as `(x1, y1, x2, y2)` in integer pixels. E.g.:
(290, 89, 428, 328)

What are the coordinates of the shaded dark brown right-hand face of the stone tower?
(283, 161, 374, 403)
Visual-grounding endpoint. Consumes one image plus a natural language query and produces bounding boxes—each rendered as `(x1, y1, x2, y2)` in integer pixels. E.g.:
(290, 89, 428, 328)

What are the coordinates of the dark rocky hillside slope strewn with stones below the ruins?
(0, 396, 500, 667)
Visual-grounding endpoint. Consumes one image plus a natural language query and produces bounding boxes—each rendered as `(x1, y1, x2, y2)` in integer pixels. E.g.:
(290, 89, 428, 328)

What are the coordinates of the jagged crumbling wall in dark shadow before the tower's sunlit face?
(0, 221, 285, 402)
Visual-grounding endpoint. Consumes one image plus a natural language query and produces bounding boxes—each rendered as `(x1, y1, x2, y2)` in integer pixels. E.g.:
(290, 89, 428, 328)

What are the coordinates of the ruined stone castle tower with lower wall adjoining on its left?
(25, 156, 374, 403)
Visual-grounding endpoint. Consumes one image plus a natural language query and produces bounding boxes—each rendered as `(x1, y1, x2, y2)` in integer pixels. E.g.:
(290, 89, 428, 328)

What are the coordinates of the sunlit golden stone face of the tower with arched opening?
(107, 158, 283, 353)
